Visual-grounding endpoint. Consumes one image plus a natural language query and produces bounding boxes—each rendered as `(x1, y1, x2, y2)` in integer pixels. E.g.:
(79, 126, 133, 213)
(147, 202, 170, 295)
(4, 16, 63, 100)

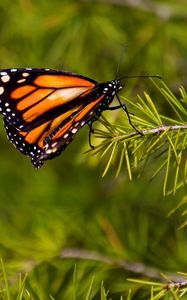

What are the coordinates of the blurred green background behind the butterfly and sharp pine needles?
(0, 0, 187, 300)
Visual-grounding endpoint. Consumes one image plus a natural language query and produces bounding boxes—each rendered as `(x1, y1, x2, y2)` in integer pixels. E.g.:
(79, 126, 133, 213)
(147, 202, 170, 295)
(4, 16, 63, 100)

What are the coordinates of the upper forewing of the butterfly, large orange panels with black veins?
(0, 69, 96, 131)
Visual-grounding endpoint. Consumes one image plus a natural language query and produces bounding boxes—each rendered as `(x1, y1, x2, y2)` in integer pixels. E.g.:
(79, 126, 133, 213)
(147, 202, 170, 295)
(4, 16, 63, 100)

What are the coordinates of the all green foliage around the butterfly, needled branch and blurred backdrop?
(0, 0, 187, 300)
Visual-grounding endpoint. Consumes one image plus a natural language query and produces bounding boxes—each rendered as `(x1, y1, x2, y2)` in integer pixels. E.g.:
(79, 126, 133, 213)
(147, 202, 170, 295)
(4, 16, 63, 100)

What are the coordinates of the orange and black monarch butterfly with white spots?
(0, 68, 161, 168)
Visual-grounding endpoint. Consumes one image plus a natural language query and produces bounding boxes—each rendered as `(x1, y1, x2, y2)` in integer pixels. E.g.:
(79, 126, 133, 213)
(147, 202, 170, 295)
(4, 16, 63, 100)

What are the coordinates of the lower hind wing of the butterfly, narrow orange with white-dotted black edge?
(4, 96, 104, 168)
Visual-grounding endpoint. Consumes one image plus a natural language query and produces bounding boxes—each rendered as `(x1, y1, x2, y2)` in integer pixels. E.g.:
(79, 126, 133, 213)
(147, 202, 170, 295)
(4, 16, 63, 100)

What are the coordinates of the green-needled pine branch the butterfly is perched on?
(89, 80, 187, 195)
